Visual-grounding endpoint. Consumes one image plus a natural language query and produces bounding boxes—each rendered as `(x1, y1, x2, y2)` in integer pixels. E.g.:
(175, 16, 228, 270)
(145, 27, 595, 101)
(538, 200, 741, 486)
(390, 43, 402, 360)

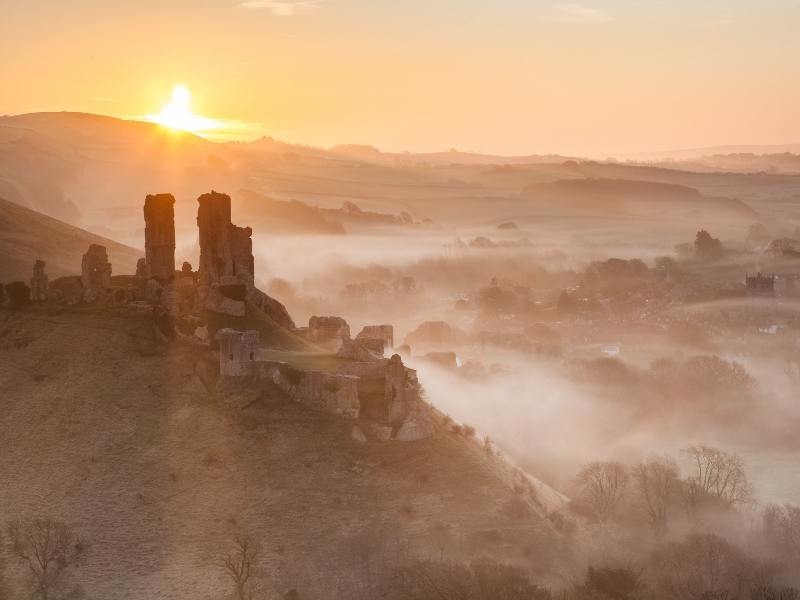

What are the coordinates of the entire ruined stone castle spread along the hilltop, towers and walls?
(25, 191, 433, 443)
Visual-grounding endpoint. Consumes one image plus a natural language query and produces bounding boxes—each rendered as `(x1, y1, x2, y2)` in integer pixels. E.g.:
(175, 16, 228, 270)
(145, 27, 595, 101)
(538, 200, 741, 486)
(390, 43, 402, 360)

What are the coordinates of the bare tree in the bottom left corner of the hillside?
(8, 519, 84, 600)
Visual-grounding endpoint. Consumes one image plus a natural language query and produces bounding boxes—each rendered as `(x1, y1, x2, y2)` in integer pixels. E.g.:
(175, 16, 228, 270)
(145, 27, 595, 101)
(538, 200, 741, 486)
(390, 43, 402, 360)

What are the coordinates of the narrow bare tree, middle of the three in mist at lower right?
(633, 456, 679, 538)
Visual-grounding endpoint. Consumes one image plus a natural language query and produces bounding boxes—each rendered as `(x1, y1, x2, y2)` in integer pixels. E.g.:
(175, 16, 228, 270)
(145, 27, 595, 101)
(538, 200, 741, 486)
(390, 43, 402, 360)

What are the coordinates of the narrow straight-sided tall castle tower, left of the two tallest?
(143, 194, 175, 283)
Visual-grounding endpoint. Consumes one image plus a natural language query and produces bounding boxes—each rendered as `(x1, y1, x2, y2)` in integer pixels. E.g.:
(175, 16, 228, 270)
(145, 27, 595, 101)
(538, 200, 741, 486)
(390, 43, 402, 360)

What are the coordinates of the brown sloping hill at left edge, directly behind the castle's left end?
(0, 199, 143, 282)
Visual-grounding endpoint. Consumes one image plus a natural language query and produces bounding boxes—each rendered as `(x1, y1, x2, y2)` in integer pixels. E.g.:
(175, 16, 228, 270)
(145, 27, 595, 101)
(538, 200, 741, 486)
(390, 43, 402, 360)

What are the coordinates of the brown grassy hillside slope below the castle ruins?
(0, 305, 558, 600)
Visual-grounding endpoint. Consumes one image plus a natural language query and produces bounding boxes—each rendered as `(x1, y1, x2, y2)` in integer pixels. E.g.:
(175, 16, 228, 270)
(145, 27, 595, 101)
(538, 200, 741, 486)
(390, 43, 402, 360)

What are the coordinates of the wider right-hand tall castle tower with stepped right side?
(197, 191, 255, 286)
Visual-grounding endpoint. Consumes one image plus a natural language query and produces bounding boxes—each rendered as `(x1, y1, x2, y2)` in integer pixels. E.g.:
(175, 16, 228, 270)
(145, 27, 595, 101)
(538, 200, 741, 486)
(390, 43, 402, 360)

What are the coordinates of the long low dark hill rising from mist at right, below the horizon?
(522, 178, 758, 222)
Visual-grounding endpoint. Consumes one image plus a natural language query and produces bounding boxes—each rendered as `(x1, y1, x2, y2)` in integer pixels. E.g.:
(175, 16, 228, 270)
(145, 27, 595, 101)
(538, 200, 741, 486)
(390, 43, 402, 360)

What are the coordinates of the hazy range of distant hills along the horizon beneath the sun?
(0, 113, 800, 236)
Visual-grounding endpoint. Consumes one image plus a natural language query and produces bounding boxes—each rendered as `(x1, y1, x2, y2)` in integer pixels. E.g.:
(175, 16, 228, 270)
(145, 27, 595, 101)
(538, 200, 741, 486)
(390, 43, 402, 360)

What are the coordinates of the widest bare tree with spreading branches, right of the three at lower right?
(682, 444, 753, 509)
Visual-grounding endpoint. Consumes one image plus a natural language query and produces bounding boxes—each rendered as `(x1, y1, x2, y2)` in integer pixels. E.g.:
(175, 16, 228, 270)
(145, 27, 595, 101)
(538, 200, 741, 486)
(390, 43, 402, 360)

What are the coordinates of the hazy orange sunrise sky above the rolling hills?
(0, 0, 800, 154)
